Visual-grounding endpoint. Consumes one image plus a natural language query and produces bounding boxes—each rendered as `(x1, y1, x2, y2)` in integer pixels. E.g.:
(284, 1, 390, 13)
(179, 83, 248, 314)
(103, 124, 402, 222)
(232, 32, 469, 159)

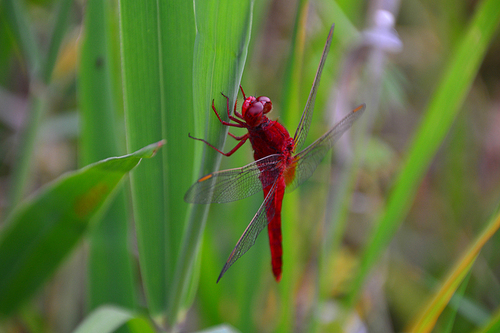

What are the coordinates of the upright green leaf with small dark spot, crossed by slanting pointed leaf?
(78, 0, 136, 309)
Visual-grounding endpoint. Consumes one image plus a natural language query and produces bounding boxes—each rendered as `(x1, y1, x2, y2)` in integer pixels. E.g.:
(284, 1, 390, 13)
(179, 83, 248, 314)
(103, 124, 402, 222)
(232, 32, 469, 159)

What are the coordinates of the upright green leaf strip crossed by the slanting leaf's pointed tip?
(119, 0, 170, 315)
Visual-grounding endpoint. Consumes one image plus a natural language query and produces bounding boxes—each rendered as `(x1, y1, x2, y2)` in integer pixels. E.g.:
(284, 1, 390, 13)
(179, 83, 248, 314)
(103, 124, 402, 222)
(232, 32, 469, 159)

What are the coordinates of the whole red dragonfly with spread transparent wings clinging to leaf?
(184, 26, 365, 282)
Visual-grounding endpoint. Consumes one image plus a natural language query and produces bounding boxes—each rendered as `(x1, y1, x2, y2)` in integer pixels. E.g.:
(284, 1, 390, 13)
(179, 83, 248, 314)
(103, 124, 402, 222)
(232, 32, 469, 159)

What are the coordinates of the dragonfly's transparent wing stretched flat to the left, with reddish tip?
(184, 154, 282, 204)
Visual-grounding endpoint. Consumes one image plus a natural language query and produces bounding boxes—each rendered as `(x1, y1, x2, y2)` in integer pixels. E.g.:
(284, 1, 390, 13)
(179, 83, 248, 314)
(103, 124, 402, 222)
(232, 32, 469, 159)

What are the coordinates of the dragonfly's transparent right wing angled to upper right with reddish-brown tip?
(286, 104, 366, 192)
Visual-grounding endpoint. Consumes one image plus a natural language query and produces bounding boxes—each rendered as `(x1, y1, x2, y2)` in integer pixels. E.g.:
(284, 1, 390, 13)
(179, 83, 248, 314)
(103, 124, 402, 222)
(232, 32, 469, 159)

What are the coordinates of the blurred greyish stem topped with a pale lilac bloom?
(313, 0, 402, 325)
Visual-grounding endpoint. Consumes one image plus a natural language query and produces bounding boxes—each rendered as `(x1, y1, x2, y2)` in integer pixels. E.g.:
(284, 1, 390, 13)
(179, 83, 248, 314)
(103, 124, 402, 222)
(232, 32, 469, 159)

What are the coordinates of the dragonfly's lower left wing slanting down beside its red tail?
(217, 182, 277, 283)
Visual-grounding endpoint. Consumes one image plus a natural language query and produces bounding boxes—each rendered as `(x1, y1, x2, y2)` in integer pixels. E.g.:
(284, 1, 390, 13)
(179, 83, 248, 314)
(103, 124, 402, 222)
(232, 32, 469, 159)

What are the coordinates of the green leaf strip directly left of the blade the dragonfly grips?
(159, 0, 196, 306)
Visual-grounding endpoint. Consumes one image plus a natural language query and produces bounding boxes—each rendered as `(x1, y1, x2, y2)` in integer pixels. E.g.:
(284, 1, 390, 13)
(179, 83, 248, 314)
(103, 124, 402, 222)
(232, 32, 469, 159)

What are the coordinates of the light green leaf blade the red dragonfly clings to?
(169, 0, 253, 322)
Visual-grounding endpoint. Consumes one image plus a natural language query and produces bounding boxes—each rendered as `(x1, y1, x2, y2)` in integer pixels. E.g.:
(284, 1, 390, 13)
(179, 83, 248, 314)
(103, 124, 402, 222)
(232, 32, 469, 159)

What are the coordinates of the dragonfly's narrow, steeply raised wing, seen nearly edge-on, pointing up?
(293, 25, 334, 152)
